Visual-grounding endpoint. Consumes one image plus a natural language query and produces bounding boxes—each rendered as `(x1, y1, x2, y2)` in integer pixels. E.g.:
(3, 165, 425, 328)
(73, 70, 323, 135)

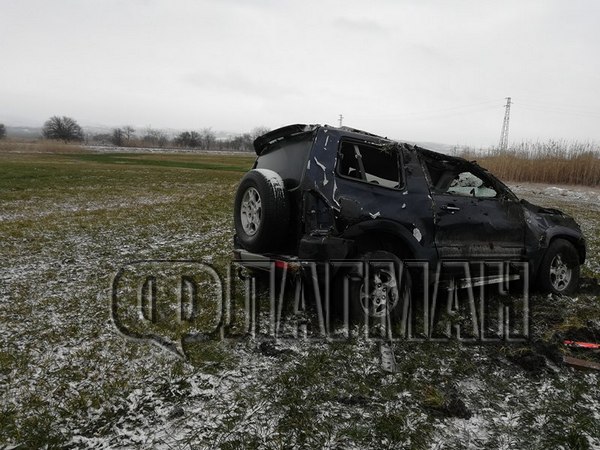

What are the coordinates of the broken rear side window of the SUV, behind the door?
(337, 141, 402, 189)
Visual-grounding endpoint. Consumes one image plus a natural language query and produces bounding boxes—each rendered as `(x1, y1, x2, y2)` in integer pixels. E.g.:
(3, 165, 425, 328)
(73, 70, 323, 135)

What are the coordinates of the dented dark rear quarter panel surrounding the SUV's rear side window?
(300, 127, 437, 259)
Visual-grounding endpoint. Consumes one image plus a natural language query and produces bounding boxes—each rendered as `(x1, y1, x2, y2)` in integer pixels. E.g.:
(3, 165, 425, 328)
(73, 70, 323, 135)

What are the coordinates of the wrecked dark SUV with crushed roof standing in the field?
(234, 125, 586, 308)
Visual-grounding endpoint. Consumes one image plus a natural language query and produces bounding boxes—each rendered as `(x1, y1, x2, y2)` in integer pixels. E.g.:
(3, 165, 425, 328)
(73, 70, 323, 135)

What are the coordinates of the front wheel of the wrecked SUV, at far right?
(538, 239, 579, 294)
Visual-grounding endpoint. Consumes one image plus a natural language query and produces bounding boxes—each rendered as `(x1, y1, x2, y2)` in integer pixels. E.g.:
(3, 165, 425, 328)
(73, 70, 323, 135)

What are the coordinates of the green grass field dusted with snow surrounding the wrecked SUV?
(0, 148, 600, 449)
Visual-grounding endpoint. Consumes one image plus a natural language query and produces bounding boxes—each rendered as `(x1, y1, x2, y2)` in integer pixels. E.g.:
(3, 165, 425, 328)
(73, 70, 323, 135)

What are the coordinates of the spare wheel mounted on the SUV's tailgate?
(234, 169, 290, 253)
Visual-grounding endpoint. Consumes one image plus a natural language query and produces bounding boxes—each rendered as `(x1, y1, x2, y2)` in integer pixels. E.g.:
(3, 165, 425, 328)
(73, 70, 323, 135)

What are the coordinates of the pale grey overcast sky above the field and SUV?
(0, 0, 600, 146)
